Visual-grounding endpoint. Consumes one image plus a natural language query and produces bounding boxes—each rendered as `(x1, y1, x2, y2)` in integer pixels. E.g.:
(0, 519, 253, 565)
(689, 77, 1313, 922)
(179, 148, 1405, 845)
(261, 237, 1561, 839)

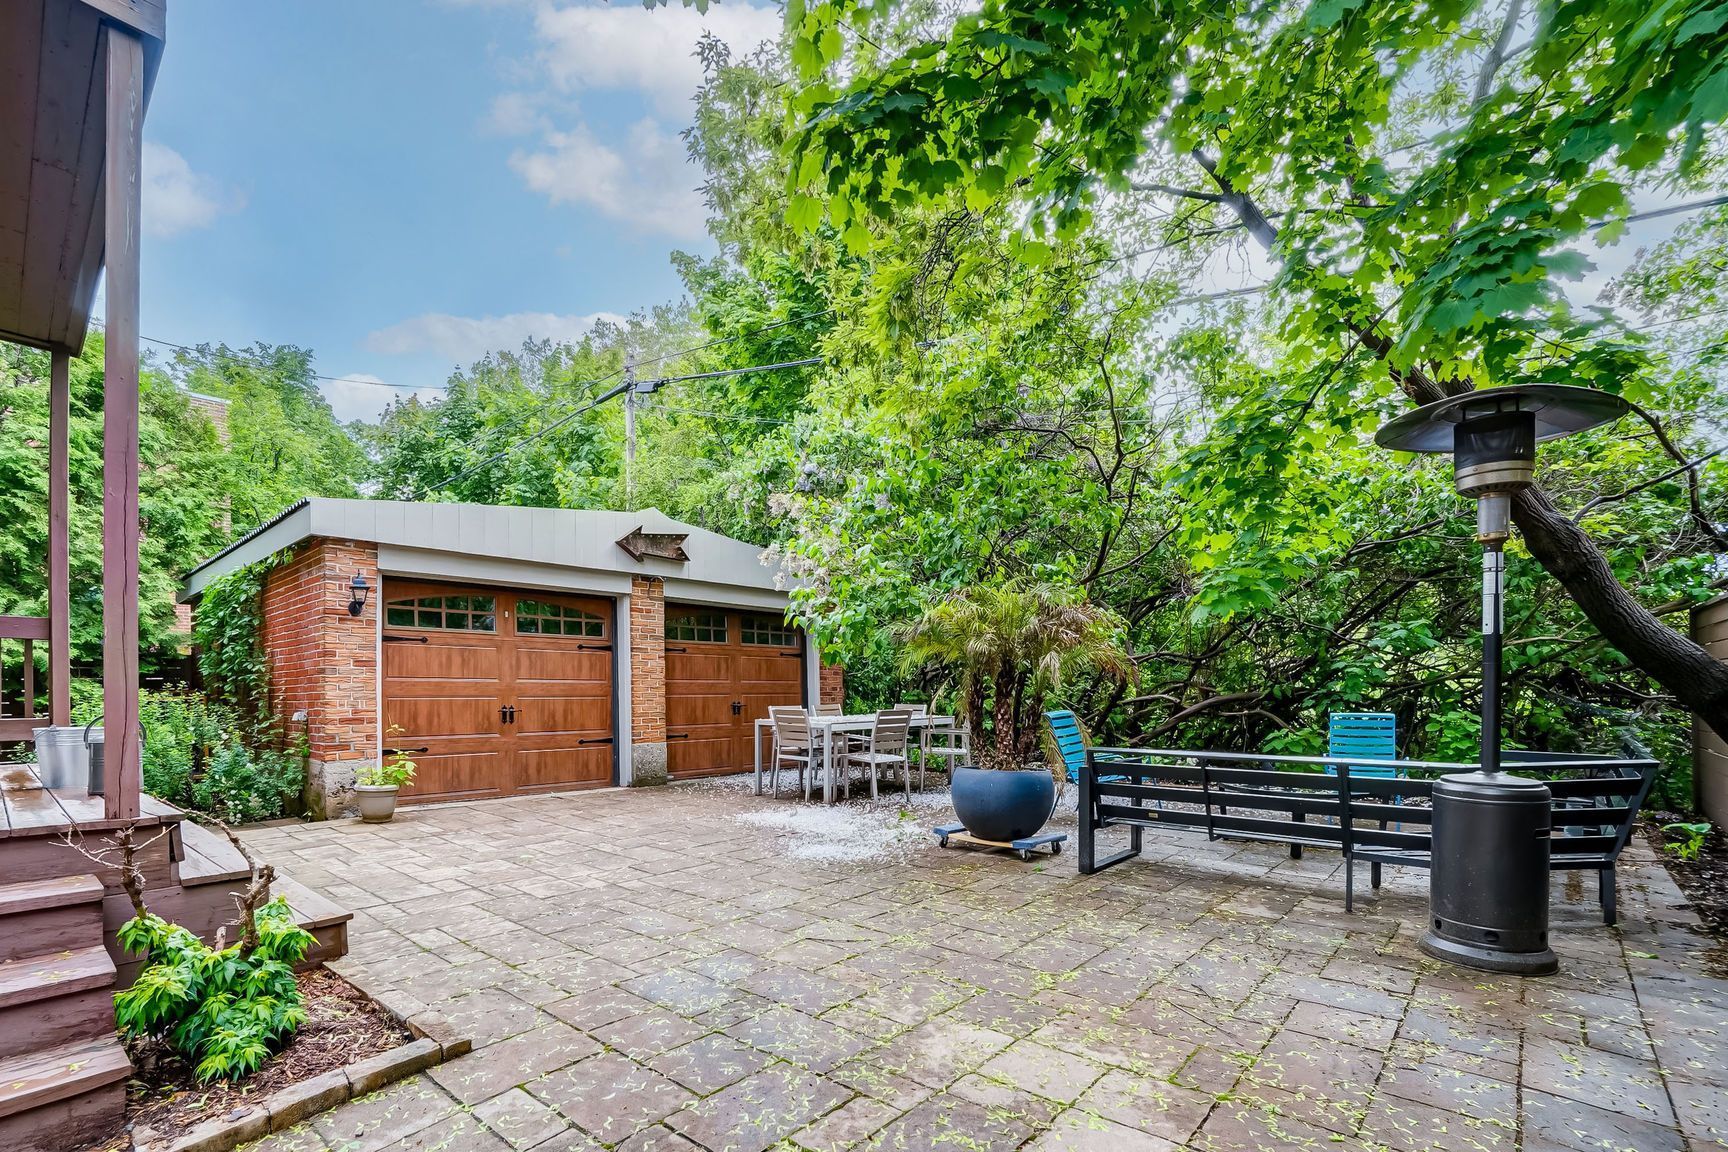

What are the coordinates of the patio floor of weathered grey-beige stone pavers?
(247, 786, 1728, 1152)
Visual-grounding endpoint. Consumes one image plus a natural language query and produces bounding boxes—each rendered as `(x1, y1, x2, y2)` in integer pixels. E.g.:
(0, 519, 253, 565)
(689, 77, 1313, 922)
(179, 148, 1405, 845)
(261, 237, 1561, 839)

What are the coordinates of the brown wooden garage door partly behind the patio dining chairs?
(665, 604, 804, 779)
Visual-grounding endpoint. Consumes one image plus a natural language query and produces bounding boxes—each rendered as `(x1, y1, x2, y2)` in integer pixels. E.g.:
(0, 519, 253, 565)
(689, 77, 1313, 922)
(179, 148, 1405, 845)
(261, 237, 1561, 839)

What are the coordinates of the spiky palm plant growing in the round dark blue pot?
(899, 580, 1134, 769)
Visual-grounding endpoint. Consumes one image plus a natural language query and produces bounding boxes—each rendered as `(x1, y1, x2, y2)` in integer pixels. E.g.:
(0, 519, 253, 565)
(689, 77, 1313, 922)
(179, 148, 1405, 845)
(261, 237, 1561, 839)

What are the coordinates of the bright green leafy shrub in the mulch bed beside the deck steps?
(114, 896, 313, 1081)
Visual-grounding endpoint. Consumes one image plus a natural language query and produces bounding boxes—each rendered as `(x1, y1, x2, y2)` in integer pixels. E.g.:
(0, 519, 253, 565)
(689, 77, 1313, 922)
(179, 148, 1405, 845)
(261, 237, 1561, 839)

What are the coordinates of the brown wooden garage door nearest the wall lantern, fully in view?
(384, 580, 613, 801)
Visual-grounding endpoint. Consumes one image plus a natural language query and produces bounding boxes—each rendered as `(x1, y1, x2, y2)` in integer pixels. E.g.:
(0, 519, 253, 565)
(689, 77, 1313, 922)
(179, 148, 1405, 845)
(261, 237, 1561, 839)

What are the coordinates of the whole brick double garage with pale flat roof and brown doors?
(185, 499, 845, 815)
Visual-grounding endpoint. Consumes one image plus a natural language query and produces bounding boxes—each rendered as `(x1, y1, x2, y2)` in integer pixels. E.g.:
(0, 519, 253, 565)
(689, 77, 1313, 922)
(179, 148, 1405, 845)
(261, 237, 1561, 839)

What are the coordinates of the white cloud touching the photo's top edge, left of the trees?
(534, 2, 781, 119)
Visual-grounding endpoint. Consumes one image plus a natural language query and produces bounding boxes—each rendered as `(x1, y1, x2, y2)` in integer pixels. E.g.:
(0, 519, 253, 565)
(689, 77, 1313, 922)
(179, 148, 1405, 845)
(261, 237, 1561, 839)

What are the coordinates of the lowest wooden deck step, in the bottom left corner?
(0, 1036, 131, 1152)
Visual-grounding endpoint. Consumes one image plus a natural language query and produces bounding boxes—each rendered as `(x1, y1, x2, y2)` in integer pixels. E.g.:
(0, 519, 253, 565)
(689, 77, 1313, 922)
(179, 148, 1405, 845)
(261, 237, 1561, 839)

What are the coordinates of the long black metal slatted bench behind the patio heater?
(1077, 748, 1657, 924)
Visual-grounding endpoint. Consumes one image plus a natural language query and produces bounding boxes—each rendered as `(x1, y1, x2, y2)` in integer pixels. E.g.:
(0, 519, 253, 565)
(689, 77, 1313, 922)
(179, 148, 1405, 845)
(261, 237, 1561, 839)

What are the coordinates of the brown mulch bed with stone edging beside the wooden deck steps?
(85, 967, 413, 1152)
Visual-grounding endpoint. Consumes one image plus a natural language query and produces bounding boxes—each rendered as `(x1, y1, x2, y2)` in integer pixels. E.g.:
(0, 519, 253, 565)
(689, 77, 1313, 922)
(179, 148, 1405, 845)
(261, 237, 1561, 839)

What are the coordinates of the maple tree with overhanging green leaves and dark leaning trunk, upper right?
(788, 0, 1728, 732)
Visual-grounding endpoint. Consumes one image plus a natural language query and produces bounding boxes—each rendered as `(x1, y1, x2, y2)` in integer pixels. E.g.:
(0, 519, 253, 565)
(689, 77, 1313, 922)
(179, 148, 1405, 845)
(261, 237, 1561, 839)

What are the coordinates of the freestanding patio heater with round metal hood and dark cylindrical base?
(1374, 383, 1630, 976)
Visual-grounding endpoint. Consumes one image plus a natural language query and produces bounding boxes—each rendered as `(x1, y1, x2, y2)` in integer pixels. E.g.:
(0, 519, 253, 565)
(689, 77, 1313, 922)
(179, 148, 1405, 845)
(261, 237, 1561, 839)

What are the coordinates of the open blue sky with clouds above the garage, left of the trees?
(142, 0, 779, 418)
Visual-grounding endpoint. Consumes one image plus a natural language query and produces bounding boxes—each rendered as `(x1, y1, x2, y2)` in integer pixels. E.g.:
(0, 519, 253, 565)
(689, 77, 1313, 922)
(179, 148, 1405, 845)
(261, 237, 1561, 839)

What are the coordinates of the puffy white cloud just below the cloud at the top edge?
(510, 119, 707, 238)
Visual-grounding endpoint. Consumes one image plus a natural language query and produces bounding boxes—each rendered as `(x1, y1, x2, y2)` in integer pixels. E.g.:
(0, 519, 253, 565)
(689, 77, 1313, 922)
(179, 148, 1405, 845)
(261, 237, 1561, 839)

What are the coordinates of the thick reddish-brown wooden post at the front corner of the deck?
(102, 24, 143, 820)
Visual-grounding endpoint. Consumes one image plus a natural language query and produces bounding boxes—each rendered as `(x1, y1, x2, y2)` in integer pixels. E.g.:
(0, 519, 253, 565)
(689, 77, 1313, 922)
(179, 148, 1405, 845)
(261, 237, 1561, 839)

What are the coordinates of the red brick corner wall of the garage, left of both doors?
(264, 539, 380, 763)
